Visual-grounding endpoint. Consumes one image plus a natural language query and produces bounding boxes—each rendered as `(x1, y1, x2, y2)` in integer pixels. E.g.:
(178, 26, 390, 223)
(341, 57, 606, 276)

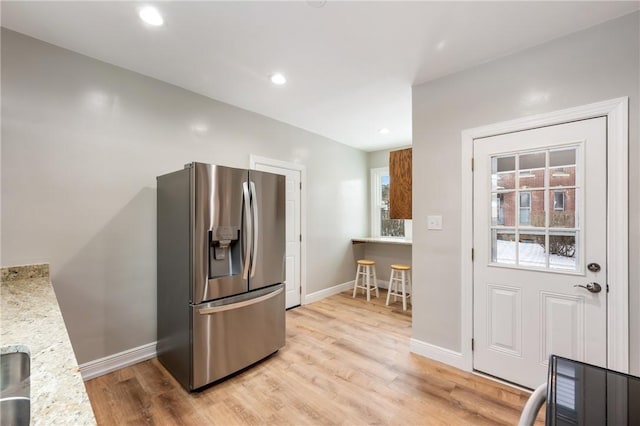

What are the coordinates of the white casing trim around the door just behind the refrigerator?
(249, 154, 307, 306)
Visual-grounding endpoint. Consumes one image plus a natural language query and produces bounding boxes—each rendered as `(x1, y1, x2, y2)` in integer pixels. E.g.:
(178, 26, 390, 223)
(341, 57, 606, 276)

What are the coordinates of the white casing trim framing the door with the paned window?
(460, 97, 629, 373)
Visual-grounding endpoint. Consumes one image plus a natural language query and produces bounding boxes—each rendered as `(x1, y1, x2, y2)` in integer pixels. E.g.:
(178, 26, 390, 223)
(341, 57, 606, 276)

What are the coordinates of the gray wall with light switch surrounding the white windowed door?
(413, 13, 640, 374)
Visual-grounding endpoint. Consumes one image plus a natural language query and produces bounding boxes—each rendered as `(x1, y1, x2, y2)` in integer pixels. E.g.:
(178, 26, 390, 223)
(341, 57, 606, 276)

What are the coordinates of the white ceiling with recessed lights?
(1, 0, 640, 151)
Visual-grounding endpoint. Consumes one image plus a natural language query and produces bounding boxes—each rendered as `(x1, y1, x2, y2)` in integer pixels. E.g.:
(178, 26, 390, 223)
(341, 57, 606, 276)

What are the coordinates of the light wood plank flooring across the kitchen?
(86, 290, 544, 425)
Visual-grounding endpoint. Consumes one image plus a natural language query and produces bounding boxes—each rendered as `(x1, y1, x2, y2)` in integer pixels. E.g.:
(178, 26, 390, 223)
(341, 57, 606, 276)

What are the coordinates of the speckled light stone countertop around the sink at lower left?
(0, 268, 96, 426)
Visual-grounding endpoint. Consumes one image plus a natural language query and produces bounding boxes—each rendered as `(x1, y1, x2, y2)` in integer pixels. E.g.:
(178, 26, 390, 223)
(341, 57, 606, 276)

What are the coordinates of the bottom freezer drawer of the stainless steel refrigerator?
(191, 284, 285, 390)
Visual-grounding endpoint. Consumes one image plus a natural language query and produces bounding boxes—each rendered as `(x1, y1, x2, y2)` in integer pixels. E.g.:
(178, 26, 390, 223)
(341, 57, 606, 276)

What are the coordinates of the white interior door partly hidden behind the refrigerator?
(255, 163, 301, 309)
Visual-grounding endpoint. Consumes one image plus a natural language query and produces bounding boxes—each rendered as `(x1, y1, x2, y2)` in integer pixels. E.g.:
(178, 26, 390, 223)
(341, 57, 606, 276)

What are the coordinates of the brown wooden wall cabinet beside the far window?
(389, 148, 412, 219)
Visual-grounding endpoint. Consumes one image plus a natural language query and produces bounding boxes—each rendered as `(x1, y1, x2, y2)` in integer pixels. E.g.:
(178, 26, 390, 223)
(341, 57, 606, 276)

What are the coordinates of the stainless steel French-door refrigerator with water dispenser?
(157, 163, 285, 390)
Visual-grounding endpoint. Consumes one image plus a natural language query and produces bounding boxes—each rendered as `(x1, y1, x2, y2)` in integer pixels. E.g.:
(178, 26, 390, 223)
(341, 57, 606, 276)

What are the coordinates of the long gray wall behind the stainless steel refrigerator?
(2, 29, 369, 363)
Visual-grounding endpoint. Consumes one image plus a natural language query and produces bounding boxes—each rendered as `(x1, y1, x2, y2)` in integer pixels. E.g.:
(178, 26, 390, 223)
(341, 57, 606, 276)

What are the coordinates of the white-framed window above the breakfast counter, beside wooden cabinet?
(371, 167, 411, 238)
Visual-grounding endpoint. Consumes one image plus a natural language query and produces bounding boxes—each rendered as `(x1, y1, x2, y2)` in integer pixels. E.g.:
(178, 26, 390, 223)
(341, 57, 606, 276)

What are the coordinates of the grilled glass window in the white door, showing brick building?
(490, 145, 582, 272)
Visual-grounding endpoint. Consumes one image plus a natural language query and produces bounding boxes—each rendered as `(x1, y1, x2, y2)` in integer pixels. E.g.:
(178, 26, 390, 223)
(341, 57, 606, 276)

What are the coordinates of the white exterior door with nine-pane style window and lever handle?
(473, 117, 607, 388)
